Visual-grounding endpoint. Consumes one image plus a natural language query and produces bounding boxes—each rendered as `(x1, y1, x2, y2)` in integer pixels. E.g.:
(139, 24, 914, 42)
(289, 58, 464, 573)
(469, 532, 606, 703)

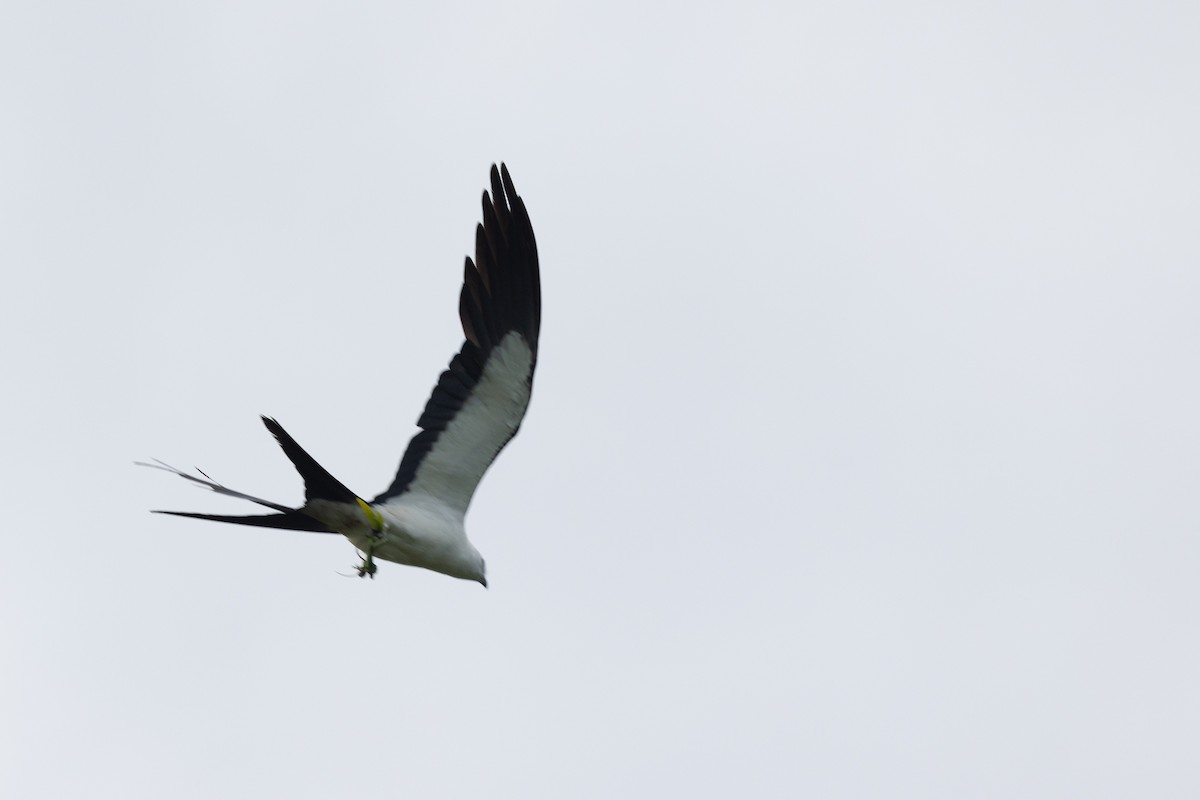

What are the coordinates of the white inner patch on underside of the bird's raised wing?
(380, 331, 533, 522)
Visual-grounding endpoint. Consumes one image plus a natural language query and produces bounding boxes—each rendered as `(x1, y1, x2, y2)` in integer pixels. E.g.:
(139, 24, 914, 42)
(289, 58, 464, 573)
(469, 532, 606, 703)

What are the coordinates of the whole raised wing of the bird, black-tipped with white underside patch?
(373, 164, 541, 516)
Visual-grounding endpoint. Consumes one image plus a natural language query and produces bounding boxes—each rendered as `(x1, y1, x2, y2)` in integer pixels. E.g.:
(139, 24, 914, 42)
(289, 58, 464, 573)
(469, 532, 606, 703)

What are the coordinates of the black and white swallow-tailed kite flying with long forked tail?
(143, 164, 541, 587)
